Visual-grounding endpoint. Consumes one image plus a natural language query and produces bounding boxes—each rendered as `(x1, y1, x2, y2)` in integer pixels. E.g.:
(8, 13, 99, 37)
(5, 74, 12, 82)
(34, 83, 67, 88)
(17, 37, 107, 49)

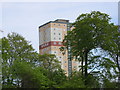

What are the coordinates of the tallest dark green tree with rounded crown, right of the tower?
(63, 11, 118, 85)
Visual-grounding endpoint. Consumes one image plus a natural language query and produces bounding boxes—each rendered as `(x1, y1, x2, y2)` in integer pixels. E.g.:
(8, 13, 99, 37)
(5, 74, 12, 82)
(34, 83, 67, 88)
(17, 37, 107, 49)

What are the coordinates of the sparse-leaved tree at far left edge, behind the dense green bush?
(2, 33, 37, 87)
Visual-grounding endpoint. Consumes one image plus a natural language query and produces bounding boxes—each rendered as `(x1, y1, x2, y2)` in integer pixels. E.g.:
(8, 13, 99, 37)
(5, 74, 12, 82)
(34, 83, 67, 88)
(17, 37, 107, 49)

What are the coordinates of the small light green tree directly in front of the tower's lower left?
(37, 54, 61, 80)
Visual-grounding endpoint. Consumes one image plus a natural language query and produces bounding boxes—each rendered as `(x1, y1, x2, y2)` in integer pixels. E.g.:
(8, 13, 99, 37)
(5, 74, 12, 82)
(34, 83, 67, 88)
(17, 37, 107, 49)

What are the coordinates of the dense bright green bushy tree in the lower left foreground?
(12, 61, 54, 88)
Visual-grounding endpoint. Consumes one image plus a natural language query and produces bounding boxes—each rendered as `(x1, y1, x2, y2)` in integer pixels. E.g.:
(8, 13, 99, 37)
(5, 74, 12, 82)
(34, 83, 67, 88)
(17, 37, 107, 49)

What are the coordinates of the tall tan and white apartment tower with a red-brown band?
(39, 19, 78, 75)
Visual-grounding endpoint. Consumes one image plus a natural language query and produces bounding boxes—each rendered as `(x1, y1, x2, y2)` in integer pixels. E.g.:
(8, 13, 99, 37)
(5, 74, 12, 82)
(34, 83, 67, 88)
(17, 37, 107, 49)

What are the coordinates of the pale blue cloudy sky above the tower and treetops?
(0, 2, 118, 51)
